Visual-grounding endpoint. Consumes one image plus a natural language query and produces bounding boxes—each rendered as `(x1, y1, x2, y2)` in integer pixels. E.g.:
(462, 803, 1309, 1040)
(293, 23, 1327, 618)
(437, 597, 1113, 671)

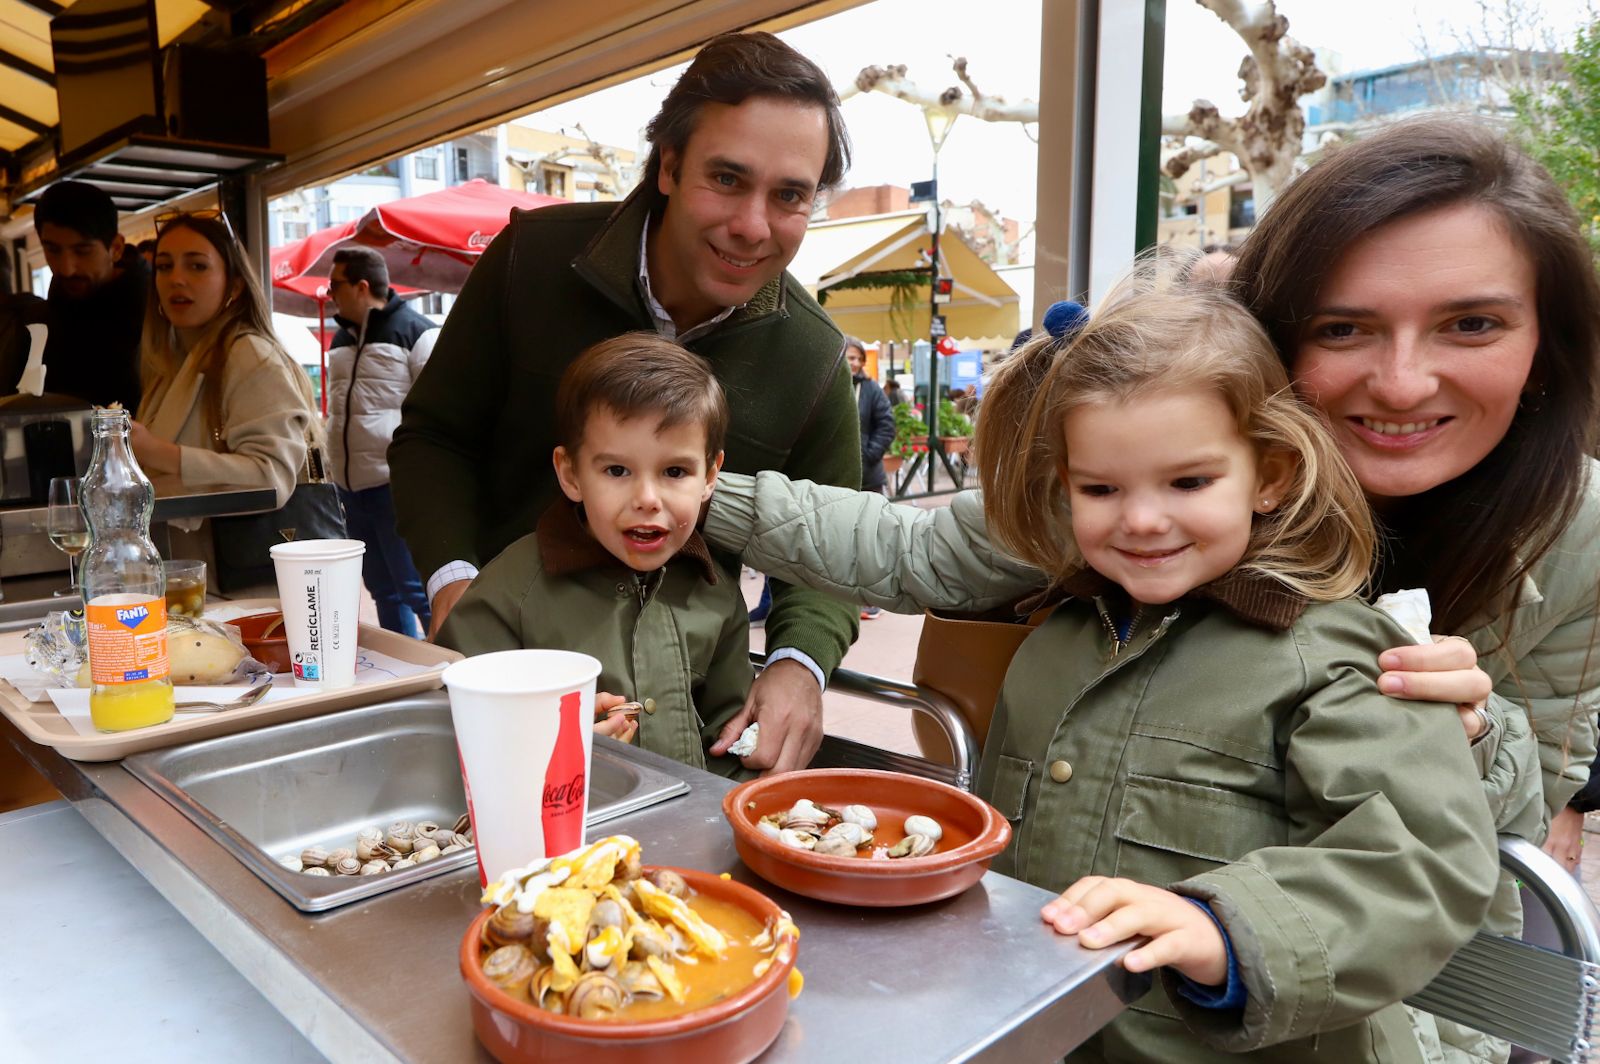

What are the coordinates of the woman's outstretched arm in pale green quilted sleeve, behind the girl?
(706, 472, 1046, 613)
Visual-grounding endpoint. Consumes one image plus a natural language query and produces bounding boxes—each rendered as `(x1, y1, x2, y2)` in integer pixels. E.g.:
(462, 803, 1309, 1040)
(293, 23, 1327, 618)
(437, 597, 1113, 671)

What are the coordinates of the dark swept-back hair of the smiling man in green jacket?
(643, 32, 850, 189)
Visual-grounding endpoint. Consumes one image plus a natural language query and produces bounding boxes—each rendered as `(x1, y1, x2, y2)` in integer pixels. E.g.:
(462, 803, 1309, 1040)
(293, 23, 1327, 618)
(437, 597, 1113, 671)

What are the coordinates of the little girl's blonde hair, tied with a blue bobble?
(974, 251, 1376, 602)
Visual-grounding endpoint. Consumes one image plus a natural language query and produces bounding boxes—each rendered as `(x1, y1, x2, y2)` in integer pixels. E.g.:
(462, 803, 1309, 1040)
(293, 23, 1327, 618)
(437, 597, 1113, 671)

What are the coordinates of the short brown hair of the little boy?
(555, 333, 728, 462)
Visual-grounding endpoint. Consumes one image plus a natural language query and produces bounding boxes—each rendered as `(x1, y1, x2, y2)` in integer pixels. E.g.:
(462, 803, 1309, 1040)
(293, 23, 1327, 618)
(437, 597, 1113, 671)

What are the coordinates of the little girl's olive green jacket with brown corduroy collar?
(978, 571, 1499, 1062)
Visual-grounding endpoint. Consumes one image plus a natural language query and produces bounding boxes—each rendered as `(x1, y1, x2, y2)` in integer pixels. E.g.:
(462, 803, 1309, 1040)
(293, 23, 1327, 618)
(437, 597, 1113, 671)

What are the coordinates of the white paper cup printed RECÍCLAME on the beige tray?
(272, 539, 366, 691)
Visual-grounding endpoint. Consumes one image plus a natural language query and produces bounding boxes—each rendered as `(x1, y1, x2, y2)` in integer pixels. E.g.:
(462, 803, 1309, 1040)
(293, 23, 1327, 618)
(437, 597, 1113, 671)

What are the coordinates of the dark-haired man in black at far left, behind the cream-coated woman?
(27, 181, 150, 411)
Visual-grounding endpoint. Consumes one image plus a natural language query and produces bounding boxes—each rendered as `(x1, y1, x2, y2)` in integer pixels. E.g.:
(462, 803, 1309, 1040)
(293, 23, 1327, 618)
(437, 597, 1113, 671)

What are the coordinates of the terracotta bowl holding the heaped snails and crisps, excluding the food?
(461, 866, 798, 1064)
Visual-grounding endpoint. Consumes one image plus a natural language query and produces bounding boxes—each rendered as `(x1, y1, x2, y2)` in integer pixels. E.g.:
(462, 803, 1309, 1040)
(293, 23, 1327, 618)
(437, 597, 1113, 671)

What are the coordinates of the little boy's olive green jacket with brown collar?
(438, 501, 752, 776)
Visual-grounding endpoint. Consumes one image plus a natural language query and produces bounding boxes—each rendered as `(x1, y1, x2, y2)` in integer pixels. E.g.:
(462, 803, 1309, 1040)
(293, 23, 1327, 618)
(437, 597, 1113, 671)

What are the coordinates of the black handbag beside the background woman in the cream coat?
(211, 440, 349, 595)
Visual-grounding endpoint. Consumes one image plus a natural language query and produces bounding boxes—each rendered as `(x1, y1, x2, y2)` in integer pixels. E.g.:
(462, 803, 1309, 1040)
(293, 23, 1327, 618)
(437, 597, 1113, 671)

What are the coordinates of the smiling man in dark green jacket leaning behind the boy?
(389, 34, 861, 771)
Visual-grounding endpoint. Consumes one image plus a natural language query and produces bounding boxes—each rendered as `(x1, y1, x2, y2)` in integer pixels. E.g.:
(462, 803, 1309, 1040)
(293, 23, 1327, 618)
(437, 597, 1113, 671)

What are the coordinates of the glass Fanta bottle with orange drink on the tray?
(83, 410, 173, 731)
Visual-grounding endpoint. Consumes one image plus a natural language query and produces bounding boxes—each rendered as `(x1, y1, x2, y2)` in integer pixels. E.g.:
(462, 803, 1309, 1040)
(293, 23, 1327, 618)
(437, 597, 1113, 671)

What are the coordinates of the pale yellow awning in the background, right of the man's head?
(789, 210, 1019, 344)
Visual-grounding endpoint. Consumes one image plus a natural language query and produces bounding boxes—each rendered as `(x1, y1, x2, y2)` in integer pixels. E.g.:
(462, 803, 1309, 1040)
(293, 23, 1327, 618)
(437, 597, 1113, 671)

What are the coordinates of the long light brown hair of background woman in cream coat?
(139, 214, 320, 437)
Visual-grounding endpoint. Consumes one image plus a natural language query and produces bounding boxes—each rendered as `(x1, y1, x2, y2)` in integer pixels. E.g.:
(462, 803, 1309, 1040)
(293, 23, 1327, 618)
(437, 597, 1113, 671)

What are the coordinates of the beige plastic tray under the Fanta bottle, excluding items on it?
(0, 598, 461, 762)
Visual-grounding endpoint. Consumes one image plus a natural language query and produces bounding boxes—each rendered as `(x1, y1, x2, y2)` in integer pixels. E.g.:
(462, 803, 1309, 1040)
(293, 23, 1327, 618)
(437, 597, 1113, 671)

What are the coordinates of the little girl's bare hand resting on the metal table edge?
(1040, 875, 1227, 986)
